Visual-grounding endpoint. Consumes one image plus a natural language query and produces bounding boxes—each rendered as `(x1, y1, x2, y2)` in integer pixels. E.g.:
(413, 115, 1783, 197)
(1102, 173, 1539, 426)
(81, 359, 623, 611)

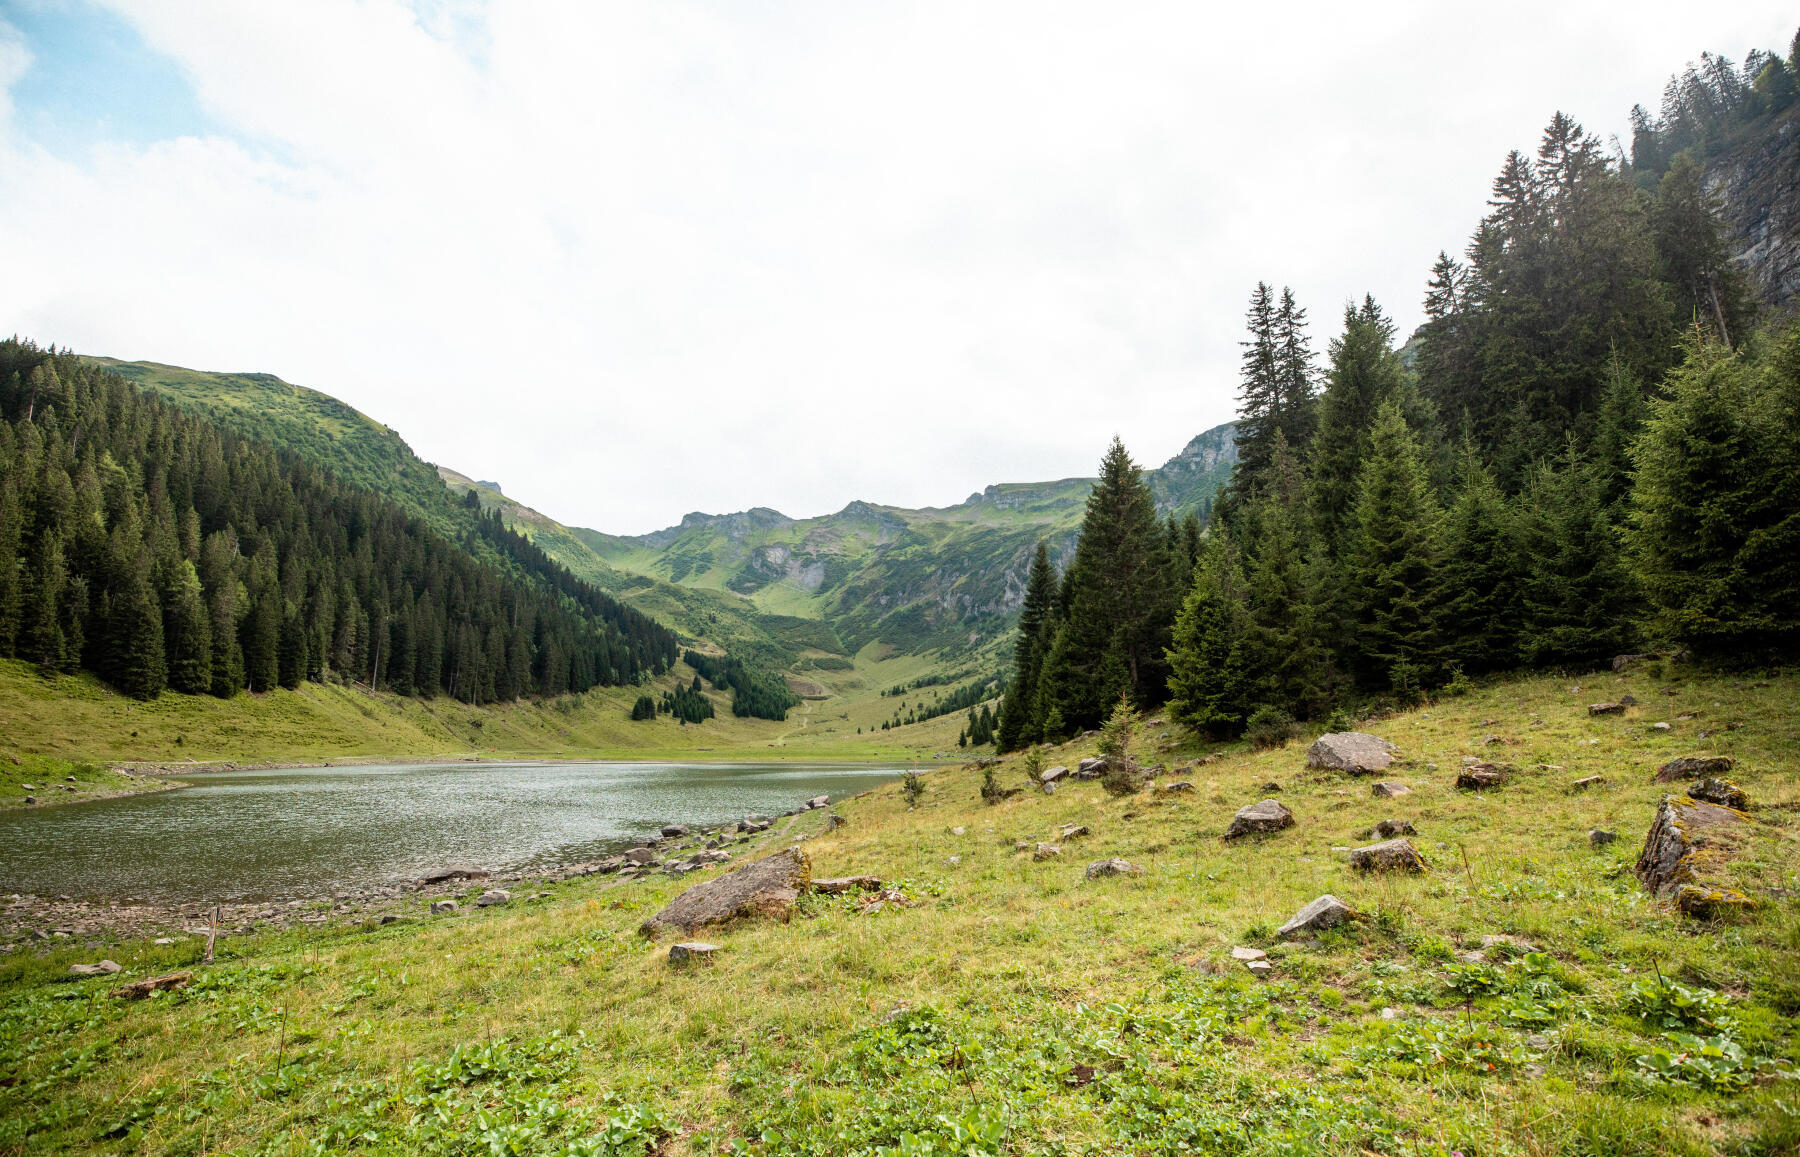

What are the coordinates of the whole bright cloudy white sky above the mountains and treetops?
(0, 0, 1796, 534)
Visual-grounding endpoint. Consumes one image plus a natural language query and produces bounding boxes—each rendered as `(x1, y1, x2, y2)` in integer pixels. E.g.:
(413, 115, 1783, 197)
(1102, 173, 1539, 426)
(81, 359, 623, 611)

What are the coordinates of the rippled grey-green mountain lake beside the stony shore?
(0, 763, 900, 901)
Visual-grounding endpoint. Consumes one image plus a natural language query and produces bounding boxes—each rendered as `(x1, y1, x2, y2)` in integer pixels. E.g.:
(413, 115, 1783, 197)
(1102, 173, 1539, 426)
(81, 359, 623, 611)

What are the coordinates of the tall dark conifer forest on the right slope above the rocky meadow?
(997, 40, 1800, 750)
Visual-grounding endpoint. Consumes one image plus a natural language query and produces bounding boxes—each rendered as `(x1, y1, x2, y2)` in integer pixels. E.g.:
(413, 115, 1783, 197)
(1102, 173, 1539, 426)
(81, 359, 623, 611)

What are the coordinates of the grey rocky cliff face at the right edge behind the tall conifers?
(1706, 104, 1800, 311)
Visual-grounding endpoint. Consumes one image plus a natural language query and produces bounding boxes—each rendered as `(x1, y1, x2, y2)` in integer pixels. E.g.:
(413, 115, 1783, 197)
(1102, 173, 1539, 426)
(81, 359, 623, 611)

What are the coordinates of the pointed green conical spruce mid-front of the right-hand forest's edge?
(1343, 399, 1442, 696)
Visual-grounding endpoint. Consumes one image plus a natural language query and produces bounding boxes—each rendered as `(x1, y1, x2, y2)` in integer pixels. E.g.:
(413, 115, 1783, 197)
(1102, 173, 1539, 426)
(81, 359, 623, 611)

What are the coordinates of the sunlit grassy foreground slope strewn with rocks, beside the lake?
(0, 675, 1800, 1157)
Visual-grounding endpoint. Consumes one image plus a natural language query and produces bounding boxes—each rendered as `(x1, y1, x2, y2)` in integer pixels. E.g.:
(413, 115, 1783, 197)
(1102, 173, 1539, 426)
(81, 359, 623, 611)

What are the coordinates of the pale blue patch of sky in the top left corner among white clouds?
(0, 0, 225, 158)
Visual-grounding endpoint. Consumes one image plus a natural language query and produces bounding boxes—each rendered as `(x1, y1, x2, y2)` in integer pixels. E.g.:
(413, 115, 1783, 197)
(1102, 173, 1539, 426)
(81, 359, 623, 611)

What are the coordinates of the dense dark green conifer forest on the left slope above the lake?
(0, 338, 677, 704)
